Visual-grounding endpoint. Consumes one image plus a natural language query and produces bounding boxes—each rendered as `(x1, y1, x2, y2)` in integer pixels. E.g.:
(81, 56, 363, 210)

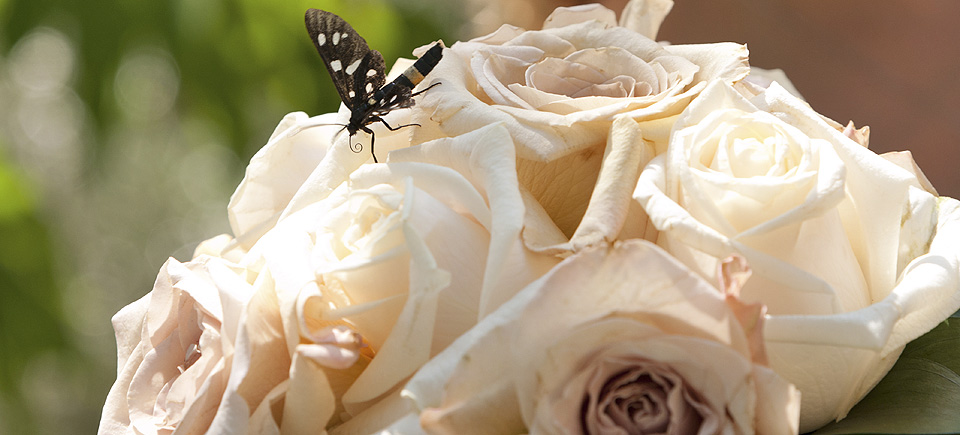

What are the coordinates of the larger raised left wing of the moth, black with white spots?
(304, 9, 384, 110)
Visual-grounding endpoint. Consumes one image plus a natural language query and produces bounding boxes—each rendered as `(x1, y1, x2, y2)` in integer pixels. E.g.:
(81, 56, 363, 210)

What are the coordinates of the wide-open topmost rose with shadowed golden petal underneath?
(413, 1, 749, 244)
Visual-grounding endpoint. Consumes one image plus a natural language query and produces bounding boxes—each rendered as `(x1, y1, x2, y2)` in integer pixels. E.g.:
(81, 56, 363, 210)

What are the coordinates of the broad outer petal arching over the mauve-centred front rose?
(403, 241, 798, 433)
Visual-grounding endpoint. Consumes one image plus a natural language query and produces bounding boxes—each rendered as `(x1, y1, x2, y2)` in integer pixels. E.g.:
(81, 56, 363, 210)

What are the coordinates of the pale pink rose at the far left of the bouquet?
(100, 256, 266, 434)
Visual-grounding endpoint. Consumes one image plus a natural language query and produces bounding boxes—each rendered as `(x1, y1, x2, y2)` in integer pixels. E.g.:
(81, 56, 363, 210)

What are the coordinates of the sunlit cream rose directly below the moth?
(225, 125, 559, 432)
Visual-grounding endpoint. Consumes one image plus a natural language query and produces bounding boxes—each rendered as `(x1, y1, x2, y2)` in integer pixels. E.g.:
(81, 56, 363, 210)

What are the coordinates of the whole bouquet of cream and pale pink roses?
(100, 0, 960, 434)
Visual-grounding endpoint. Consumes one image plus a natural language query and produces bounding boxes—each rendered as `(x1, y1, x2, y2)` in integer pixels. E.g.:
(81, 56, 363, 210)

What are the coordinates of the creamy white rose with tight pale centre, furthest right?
(635, 81, 960, 431)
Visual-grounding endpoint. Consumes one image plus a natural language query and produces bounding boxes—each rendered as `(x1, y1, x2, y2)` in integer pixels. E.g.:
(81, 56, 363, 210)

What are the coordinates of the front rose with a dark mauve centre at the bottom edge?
(399, 240, 799, 434)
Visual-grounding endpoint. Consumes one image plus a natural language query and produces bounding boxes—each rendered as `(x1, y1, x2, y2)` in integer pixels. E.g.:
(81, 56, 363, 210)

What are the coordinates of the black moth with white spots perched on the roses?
(306, 9, 443, 162)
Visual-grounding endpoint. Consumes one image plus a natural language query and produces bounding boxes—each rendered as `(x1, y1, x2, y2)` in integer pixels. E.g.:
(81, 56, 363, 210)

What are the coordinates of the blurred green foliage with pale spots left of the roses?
(0, 0, 462, 434)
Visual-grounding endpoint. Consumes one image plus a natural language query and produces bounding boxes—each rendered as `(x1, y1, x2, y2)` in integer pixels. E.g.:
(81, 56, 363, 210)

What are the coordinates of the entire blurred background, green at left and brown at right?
(0, 0, 960, 434)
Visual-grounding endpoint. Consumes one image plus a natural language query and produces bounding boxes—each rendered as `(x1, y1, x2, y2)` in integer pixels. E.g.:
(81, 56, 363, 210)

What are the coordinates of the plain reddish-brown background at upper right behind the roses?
(520, 0, 960, 198)
